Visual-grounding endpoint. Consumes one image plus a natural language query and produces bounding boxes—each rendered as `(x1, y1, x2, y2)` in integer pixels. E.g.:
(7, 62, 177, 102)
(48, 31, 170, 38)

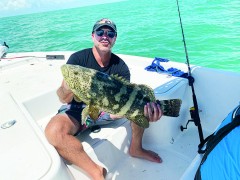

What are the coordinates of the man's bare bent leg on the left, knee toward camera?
(45, 114, 106, 180)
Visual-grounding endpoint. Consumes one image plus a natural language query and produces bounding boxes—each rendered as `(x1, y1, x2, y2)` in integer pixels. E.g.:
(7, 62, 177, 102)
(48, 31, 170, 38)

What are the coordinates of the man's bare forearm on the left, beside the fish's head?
(57, 80, 73, 103)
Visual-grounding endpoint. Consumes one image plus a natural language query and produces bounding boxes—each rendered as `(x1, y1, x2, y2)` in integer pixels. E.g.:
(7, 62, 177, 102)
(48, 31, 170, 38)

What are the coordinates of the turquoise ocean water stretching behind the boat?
(0, 0, 240, 72)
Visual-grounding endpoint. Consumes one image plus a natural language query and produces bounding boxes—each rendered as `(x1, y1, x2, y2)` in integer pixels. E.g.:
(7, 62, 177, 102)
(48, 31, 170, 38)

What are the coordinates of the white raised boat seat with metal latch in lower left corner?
(0, 93, 71, 180)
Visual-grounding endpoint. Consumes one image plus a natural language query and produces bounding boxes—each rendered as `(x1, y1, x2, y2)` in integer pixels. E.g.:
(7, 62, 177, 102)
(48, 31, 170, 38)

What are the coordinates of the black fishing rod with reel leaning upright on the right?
(176, 0, 204, 144)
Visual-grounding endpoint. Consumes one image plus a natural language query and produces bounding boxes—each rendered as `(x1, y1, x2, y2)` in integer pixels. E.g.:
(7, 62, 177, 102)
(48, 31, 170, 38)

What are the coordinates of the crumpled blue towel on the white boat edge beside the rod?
(145, 57, 188, 78)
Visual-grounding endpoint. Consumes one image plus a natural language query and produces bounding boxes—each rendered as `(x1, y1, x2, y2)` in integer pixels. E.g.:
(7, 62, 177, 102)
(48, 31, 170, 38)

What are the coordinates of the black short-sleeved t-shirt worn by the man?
(67, 48, 130, 104)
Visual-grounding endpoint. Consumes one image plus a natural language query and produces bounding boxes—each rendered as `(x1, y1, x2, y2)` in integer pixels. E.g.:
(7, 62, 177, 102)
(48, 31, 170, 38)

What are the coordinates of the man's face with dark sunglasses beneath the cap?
(92, 27, 117, 51)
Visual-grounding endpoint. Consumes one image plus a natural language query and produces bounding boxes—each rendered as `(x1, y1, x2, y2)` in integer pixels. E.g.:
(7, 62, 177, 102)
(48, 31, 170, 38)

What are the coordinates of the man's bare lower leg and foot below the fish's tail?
(129, 122, 162, 163)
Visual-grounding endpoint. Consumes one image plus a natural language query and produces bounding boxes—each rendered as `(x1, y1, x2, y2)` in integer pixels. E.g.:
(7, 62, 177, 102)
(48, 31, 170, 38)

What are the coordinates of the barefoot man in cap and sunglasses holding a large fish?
(45, 18, 162, 179)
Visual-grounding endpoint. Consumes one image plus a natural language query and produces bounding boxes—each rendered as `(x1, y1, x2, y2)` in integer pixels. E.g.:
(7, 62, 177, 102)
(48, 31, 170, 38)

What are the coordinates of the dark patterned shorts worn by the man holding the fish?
(57, 103, 113, 136)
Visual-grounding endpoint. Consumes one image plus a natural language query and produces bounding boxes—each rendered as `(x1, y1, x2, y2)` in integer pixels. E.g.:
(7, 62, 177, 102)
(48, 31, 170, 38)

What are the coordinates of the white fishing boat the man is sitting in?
(0, 52, 240, 180)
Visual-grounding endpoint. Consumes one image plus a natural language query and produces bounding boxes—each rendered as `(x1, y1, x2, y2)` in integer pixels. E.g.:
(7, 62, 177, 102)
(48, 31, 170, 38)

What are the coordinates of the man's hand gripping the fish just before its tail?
(144, 102, 162, 122)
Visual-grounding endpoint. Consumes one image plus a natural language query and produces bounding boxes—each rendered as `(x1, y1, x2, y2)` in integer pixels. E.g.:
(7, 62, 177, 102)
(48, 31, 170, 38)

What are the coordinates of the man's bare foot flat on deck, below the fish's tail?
(129, 148, 162, 163)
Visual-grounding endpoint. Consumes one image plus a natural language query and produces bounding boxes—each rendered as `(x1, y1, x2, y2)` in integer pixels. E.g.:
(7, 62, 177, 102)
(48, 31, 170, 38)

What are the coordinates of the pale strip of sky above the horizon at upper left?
(0, 0, 124, 17)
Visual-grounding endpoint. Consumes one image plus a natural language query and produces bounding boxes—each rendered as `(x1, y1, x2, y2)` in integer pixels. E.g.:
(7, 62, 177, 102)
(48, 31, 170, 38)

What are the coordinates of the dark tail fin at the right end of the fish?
(156, 99, 182, 117)
